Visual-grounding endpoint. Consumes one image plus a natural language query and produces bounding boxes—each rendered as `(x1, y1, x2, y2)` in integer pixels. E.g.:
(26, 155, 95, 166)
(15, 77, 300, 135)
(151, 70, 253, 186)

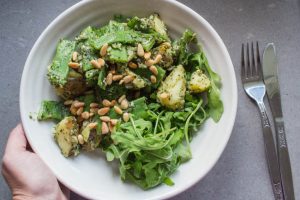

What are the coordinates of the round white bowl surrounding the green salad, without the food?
(20, 0, 237, 200)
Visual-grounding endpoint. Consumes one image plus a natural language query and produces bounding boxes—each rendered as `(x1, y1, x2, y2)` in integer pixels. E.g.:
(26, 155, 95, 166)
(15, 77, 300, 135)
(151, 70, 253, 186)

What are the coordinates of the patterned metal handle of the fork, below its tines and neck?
(257, 101, 284, 200)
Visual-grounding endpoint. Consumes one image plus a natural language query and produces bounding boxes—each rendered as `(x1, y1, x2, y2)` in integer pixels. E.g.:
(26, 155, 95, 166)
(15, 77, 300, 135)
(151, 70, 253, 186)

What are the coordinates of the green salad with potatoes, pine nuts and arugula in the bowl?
(38, 14, 223, 189)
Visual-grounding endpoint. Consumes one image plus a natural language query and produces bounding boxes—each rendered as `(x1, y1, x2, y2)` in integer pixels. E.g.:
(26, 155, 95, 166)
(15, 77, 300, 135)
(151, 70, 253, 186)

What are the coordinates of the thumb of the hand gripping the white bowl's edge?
(5, 124, 27, 154)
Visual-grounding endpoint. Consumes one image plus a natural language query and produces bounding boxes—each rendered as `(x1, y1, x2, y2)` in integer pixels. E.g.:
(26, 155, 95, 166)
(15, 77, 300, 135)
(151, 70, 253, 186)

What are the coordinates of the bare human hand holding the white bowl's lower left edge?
(2, 124, 70, 200)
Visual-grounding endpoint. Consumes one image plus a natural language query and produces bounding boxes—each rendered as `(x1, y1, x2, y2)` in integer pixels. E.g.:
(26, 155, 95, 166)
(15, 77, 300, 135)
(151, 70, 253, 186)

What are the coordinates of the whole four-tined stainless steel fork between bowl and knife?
(241, 42, 284, 200)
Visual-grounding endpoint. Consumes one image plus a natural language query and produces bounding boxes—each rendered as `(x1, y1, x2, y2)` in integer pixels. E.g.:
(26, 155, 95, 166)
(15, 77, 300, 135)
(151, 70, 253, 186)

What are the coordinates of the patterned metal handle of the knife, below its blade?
(274, 118, 295, 200)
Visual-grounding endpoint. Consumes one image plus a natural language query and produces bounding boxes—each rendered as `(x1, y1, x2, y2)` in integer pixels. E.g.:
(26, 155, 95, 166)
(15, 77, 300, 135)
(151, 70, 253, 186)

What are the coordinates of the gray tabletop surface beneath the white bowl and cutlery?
(0, 0, 300, 200)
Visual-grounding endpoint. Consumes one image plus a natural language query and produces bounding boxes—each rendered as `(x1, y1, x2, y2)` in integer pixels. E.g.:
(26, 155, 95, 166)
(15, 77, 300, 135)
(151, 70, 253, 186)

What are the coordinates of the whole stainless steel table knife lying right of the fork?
(263, 43, 295, 200)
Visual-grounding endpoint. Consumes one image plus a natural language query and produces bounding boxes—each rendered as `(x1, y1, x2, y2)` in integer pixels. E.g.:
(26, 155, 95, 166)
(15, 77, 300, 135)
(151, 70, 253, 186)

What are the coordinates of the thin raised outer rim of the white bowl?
(19, 0, 238, 199)
